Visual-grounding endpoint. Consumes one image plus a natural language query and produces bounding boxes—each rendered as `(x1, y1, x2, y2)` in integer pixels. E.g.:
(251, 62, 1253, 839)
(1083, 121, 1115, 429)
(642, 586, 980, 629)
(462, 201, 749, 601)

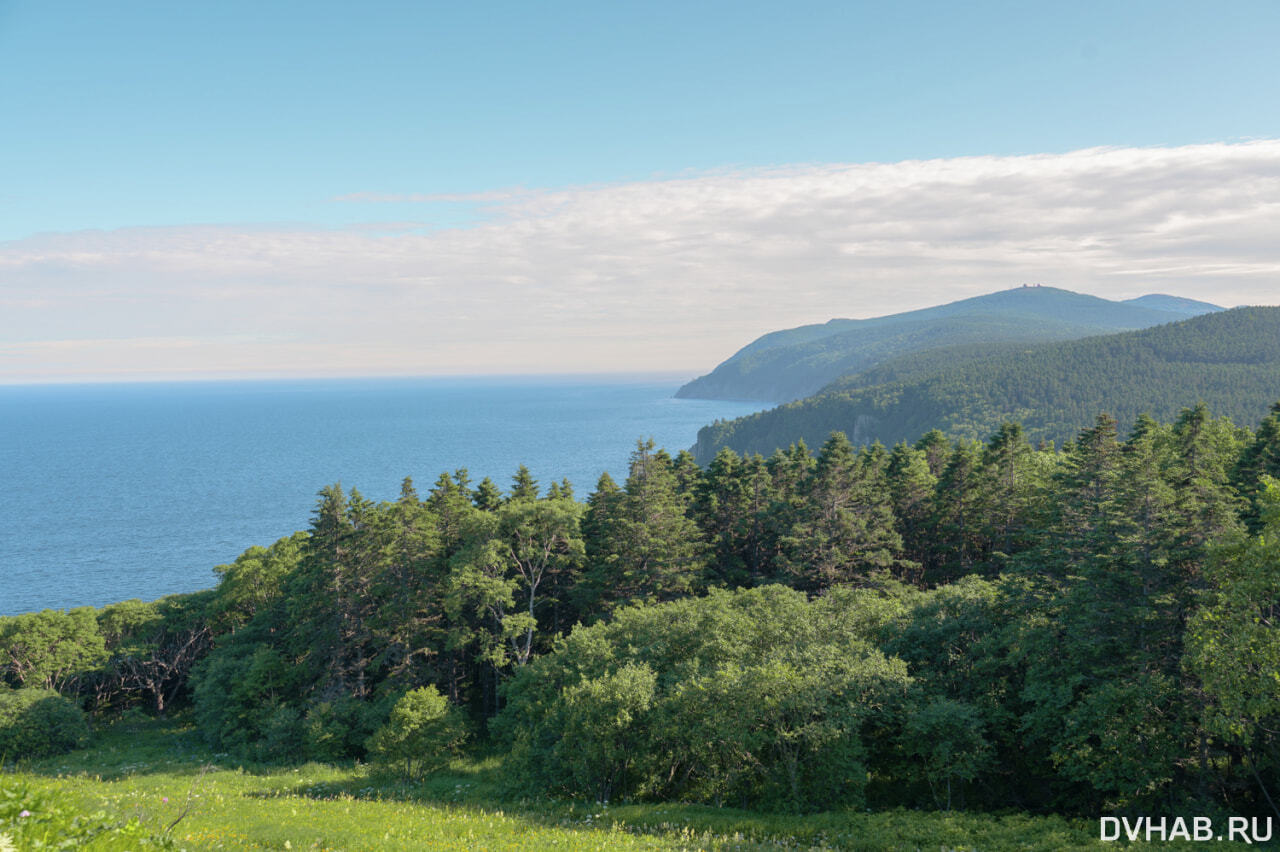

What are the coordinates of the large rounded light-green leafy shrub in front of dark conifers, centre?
(493, 586, 910, 811)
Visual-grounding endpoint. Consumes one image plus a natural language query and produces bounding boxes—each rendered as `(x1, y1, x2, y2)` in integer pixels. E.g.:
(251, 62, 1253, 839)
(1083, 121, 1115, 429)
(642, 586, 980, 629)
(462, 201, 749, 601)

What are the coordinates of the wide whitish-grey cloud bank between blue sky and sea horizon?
(0, 141, 1280, 381)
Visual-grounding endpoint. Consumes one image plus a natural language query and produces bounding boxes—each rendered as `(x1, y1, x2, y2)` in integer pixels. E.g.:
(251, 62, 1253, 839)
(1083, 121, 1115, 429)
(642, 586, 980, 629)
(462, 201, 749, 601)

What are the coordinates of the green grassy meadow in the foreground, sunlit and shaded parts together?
(0, 720, 1249, 851)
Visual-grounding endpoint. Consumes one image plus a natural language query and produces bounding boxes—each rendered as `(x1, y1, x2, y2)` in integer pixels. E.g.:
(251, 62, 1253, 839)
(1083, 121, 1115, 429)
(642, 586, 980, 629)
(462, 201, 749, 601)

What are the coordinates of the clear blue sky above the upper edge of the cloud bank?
(0, 0, 1280, 239)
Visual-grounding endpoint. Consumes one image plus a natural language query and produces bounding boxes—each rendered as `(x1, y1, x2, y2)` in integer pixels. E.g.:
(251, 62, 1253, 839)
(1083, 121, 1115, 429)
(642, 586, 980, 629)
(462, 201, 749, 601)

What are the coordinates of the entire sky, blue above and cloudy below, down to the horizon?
(0, 0, 1280, 383)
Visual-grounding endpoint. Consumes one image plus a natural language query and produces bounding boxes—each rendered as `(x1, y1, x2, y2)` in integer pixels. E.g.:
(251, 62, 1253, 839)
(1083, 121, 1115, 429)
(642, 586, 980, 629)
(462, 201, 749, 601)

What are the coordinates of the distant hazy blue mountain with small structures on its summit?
(676, 287, 1221, 402)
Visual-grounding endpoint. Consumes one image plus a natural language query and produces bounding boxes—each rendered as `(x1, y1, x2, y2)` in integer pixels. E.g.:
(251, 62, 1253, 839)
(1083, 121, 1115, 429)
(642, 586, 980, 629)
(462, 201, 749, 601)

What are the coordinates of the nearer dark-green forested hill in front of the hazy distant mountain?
(695, 307, 1280, 462)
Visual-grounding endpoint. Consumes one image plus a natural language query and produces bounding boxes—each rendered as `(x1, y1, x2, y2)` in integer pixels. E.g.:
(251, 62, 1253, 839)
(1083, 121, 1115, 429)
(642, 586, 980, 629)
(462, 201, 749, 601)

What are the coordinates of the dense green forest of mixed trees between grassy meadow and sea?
(0, 403, 1280, 816)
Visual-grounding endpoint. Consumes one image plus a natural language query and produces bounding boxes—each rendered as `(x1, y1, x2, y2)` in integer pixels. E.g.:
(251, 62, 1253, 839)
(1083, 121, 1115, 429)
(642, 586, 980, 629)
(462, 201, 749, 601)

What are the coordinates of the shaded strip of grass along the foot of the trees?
(20, 716, 1093, 849)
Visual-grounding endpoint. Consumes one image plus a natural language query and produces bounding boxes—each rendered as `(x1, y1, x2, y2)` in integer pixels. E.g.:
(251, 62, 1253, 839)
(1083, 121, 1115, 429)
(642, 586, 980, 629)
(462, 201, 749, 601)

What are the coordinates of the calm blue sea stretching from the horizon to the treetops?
(0, 376, 759, 614)
